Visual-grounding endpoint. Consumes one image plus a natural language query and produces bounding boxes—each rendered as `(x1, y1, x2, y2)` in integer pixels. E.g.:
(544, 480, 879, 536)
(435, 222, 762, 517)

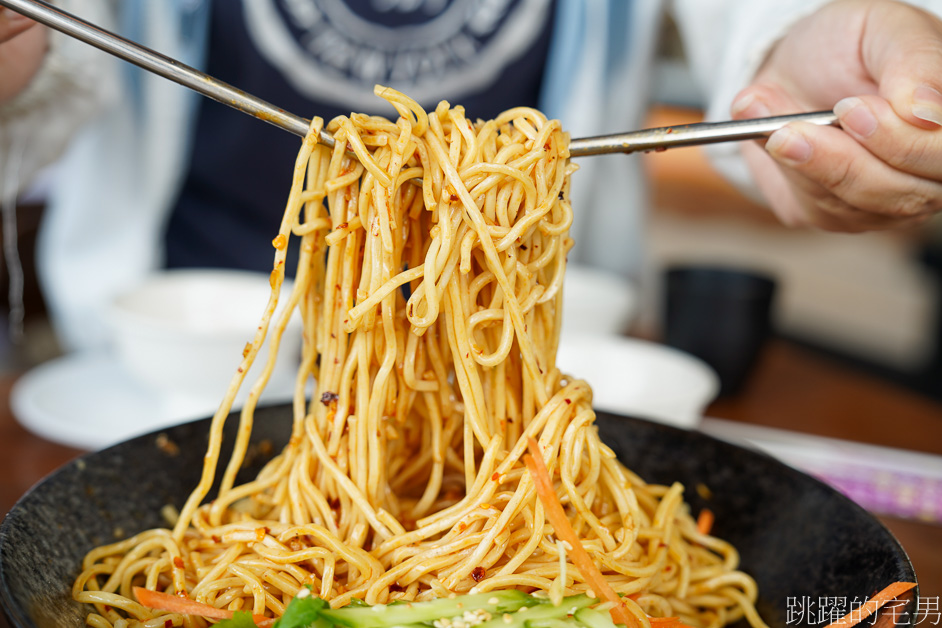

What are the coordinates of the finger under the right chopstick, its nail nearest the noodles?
(765, 123, 942, 218)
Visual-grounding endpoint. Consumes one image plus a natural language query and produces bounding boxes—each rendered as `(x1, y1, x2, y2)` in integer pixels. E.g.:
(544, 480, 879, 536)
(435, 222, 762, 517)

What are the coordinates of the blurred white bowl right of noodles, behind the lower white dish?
(562, 264, 637, 334)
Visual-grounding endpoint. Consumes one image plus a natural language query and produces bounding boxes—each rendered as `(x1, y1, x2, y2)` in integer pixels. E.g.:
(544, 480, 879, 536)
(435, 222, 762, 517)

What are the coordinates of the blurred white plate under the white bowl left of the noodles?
(10, 353, 291, 449)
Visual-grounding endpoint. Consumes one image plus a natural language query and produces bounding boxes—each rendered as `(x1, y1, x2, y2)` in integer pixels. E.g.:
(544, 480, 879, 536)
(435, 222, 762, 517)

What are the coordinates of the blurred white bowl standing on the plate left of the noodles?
(110, 270, 301, 407)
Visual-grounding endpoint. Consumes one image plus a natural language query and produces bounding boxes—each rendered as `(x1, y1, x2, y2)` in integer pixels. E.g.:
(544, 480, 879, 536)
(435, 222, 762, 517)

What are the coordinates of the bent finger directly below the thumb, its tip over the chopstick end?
(834, 96, 942, 181)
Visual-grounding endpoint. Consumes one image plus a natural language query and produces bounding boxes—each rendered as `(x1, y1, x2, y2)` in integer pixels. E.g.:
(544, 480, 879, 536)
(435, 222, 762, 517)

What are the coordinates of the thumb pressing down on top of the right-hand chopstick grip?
(861, 3, 942, 129)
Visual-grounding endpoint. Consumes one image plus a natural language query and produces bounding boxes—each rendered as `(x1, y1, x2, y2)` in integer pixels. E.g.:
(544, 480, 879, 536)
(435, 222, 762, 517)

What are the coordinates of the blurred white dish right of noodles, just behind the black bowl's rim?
(556, 333, 719, 428)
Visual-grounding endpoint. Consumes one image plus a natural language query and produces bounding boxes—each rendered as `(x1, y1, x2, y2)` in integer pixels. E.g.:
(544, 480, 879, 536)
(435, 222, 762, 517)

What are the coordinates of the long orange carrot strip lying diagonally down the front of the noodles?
(523, 438, 640, 628)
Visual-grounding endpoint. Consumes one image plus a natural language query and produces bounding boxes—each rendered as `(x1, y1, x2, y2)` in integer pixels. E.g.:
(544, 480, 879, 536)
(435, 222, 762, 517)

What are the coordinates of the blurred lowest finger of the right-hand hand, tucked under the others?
(742, 143, 927, 233)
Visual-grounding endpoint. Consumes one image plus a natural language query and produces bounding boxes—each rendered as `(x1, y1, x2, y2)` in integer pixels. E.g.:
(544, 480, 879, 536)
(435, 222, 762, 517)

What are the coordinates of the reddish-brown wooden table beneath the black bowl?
(0, 341, 942, 628)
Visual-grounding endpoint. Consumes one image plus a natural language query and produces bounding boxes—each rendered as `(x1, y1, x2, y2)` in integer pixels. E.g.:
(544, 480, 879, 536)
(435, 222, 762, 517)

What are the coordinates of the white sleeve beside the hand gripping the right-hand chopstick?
(672, 0, 942, 194)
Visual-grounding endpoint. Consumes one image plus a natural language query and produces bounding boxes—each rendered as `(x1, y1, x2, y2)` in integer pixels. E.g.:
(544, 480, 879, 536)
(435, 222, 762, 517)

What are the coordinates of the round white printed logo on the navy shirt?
(244, 0, 550, 110)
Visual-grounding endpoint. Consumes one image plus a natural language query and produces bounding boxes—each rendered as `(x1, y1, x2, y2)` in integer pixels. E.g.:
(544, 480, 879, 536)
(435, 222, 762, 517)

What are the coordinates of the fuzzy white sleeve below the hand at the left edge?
(0, 0, 118, 199)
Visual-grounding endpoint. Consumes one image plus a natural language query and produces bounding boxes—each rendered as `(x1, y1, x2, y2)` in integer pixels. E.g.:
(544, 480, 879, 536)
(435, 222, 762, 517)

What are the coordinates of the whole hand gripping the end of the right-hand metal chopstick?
(732, 0, 942, 232)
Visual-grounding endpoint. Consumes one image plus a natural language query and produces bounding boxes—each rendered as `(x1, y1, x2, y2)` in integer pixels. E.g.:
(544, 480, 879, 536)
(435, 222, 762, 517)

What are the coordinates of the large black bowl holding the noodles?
(0, 406, 918, 628)
